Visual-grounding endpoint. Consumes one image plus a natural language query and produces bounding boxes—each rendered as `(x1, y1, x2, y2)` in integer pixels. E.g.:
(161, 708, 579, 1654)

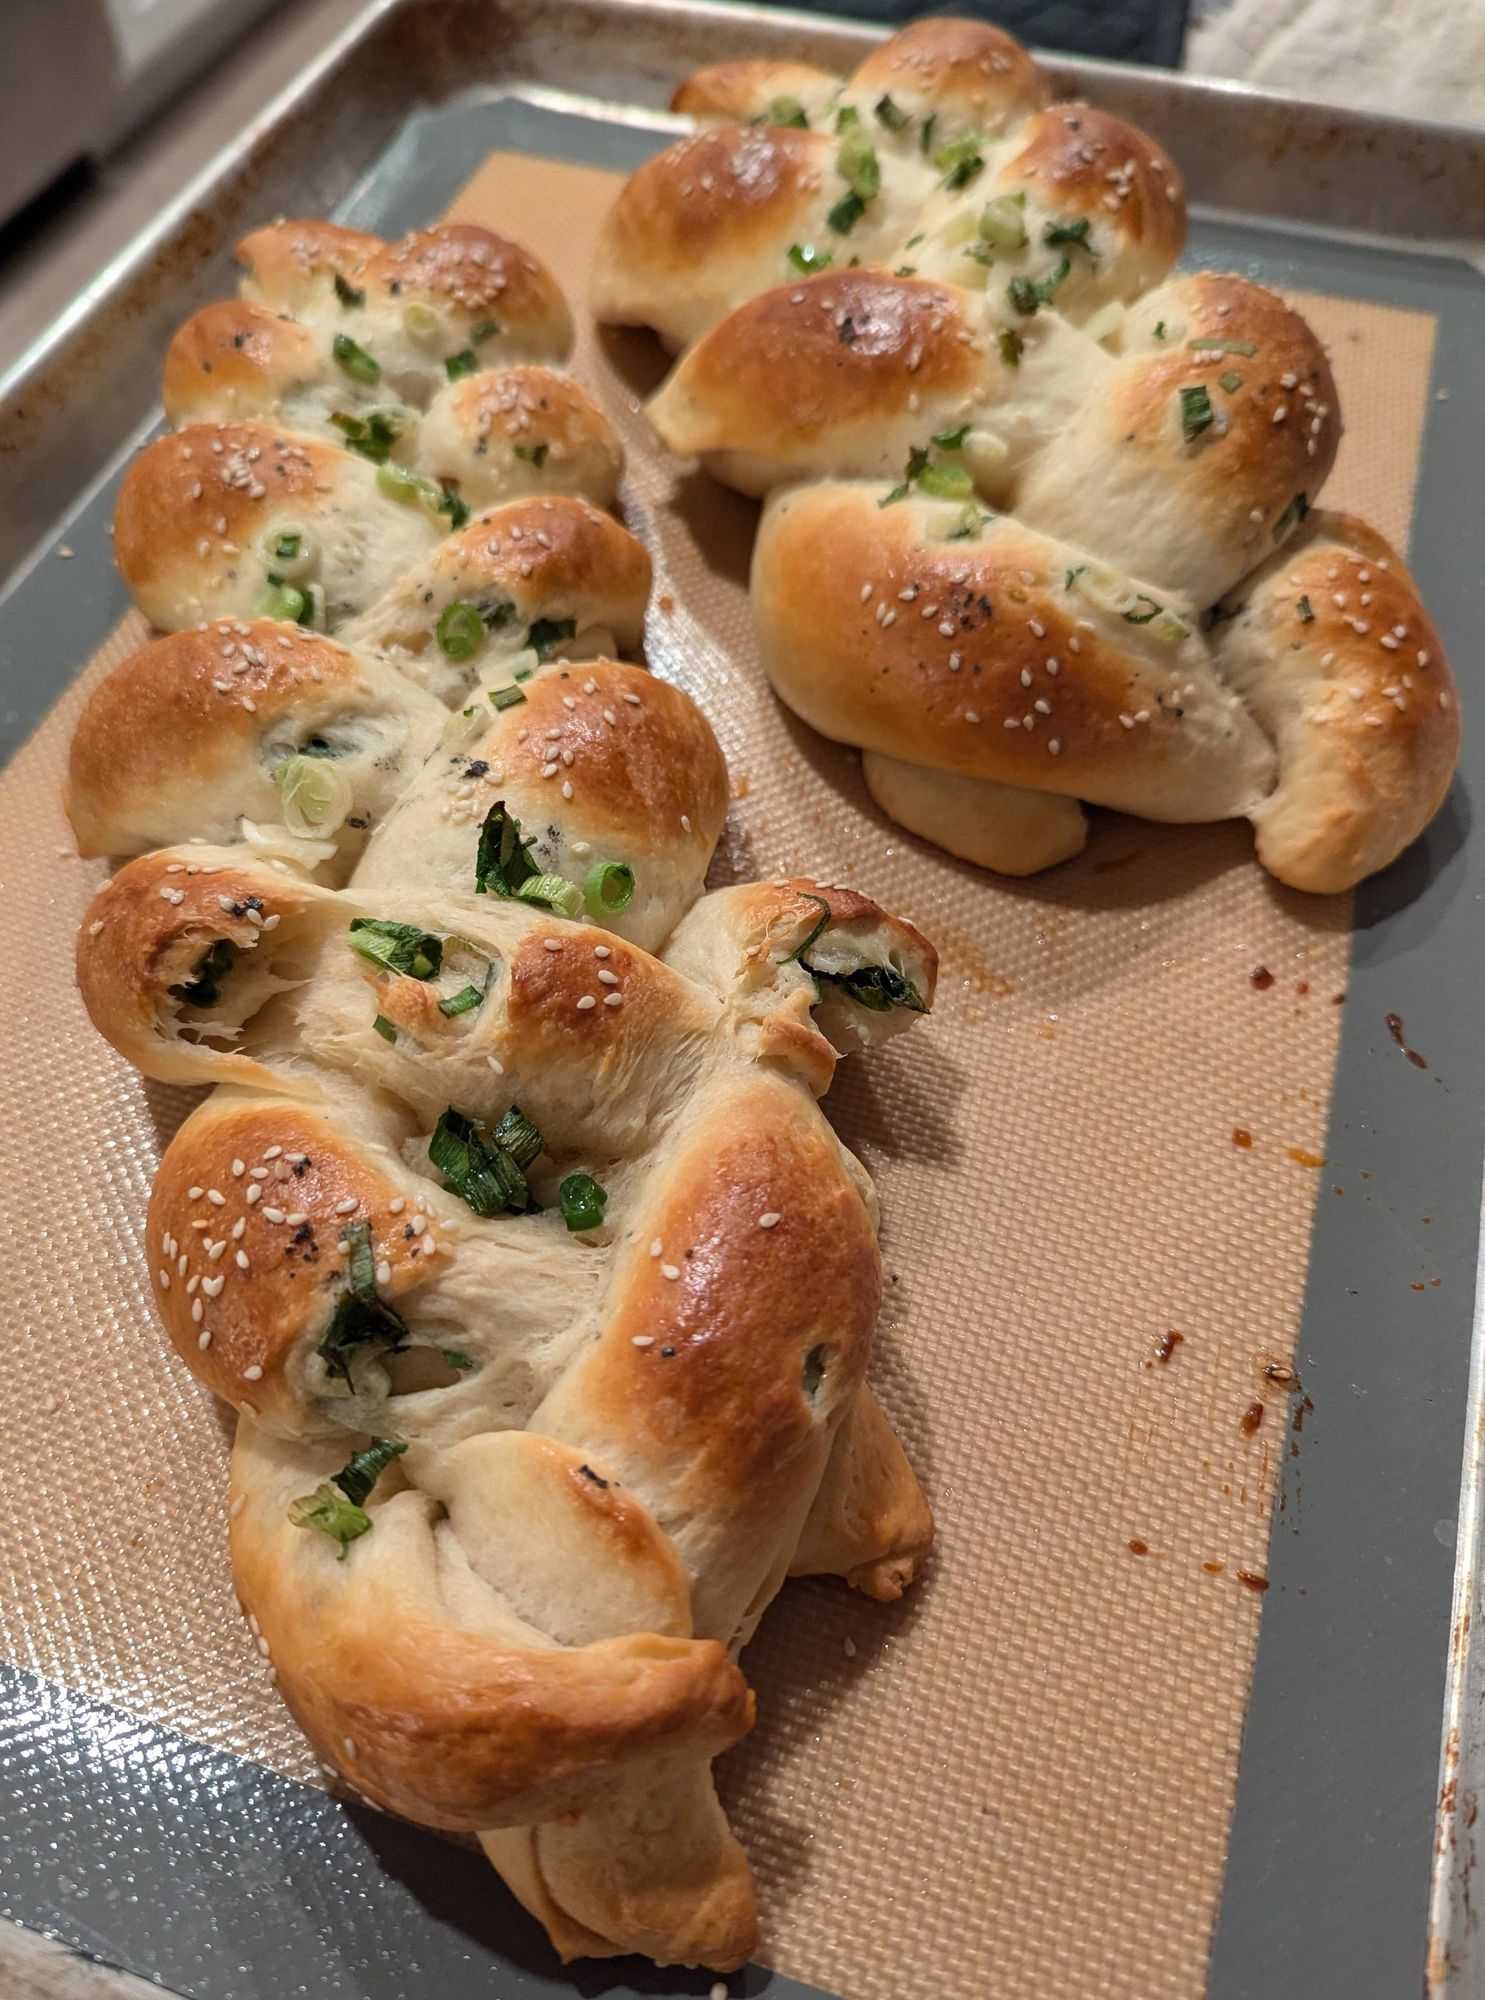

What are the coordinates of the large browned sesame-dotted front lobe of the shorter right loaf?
(753, 486, 1269, 818)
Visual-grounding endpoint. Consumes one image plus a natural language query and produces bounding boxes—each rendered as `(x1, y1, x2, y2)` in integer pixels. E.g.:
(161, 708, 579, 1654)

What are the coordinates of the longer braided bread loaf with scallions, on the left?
(68, 224, 935, 1968)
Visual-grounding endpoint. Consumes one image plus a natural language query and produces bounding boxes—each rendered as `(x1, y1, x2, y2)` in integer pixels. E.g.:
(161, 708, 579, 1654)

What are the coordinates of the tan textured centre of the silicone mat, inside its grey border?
(0, 145, 1431, 2000)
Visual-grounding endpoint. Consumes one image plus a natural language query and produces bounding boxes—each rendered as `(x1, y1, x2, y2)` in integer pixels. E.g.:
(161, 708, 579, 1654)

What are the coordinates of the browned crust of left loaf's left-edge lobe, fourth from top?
(66, 618, 364, 856)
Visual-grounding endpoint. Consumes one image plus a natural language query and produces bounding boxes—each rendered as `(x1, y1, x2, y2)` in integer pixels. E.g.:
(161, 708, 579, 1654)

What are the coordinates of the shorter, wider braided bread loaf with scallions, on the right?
(592, 20, 1459, 890)
